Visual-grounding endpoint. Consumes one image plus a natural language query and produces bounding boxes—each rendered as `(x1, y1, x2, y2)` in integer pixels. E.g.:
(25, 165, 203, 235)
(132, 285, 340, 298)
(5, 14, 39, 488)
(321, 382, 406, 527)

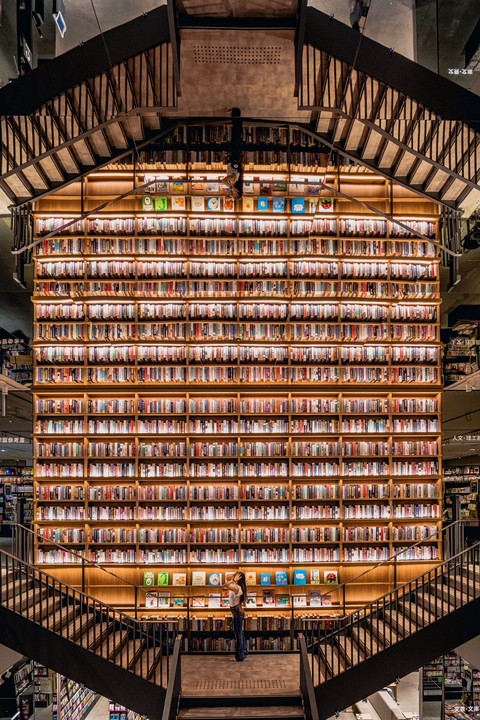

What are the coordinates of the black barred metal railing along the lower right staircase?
(310, 542, 480, 685)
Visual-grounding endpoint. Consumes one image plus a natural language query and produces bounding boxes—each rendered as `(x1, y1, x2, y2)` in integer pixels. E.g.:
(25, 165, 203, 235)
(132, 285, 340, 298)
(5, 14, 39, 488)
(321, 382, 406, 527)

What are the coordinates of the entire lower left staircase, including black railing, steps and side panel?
(0, 551, 175, 720)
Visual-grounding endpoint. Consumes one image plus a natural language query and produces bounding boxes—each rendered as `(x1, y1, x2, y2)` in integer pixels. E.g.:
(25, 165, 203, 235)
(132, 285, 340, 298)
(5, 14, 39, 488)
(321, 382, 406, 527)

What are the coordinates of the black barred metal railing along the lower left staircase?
(0, 550, 178, 687)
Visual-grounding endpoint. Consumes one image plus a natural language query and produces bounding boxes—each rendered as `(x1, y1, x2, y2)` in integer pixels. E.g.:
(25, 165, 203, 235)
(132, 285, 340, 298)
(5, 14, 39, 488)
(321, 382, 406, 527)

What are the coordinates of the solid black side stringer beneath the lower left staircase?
(0, 606, 166, 720)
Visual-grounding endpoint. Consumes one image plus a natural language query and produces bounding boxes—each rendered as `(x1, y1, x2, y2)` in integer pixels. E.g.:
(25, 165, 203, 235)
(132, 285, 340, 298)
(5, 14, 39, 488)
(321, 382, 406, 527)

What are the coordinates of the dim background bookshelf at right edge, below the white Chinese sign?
(443, 464, 480, 524)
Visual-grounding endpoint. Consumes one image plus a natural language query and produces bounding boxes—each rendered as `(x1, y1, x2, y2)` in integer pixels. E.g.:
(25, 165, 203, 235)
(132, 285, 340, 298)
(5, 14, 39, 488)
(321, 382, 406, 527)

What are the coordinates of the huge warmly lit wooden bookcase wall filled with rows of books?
(30, 160, 441, 640)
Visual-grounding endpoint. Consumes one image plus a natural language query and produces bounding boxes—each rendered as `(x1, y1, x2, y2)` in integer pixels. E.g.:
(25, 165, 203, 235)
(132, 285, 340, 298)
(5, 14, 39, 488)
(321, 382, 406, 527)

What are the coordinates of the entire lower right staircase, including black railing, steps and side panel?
(307, 543, 480, 719)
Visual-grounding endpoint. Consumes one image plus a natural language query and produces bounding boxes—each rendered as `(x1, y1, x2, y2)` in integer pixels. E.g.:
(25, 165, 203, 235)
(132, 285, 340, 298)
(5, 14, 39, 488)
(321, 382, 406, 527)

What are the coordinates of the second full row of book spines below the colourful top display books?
(36, 236, 437, 259)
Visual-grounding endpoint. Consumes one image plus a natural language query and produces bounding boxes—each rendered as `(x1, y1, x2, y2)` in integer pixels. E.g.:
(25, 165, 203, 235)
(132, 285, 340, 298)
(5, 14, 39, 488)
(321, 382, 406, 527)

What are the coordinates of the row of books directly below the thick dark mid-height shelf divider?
(35, 393, 438, 414)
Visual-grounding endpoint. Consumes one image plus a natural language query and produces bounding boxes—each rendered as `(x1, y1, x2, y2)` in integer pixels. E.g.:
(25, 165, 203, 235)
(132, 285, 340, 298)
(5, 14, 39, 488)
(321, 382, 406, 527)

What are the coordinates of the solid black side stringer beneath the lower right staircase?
(315, 598, 480, 720)
